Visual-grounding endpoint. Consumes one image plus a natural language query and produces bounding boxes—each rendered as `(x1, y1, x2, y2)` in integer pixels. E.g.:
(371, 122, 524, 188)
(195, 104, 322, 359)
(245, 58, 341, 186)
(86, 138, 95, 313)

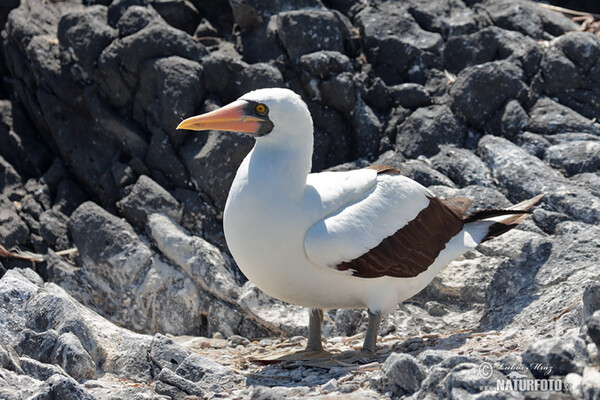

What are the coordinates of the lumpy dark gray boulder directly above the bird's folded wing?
(396, 105, 467, 158)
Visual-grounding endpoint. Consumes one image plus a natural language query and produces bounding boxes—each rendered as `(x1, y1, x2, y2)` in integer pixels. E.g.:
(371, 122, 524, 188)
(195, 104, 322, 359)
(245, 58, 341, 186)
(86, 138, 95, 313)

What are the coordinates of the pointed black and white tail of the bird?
(464, 194, 544, 243)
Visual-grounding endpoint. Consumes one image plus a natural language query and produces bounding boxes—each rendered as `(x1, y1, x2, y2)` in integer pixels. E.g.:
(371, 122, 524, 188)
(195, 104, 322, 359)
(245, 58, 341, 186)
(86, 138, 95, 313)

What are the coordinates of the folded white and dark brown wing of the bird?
(304, 171, 470, 278)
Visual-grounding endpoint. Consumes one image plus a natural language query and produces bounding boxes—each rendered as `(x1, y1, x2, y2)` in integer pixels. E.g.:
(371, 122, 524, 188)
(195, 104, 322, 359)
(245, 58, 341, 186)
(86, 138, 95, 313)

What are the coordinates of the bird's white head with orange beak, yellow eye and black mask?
(177, 88, 313, 149)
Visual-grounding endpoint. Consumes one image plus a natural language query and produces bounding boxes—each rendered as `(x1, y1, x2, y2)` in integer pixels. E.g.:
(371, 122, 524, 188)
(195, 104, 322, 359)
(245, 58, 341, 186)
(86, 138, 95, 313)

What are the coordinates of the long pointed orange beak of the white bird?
(177, 100, 262, 133)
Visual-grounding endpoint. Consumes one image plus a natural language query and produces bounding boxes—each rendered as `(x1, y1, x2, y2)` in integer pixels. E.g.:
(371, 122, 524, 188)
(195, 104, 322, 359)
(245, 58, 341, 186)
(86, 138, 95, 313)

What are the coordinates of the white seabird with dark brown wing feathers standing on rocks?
(177, 88, 541, 359)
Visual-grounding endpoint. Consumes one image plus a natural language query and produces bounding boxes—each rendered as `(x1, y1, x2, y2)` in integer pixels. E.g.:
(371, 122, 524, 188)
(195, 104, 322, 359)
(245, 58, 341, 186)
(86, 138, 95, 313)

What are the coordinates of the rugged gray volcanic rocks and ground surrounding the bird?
(0, 0, 600, 400)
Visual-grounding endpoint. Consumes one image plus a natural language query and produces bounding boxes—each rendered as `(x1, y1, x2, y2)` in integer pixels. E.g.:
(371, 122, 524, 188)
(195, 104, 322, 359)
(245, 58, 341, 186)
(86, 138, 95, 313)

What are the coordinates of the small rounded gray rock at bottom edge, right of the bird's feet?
(381, 353, 426, 396)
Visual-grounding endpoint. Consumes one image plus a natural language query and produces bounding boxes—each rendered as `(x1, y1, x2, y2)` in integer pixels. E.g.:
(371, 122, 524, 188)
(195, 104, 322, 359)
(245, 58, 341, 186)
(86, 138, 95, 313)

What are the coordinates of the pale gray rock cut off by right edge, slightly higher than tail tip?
(545, 141, 600, 176)
